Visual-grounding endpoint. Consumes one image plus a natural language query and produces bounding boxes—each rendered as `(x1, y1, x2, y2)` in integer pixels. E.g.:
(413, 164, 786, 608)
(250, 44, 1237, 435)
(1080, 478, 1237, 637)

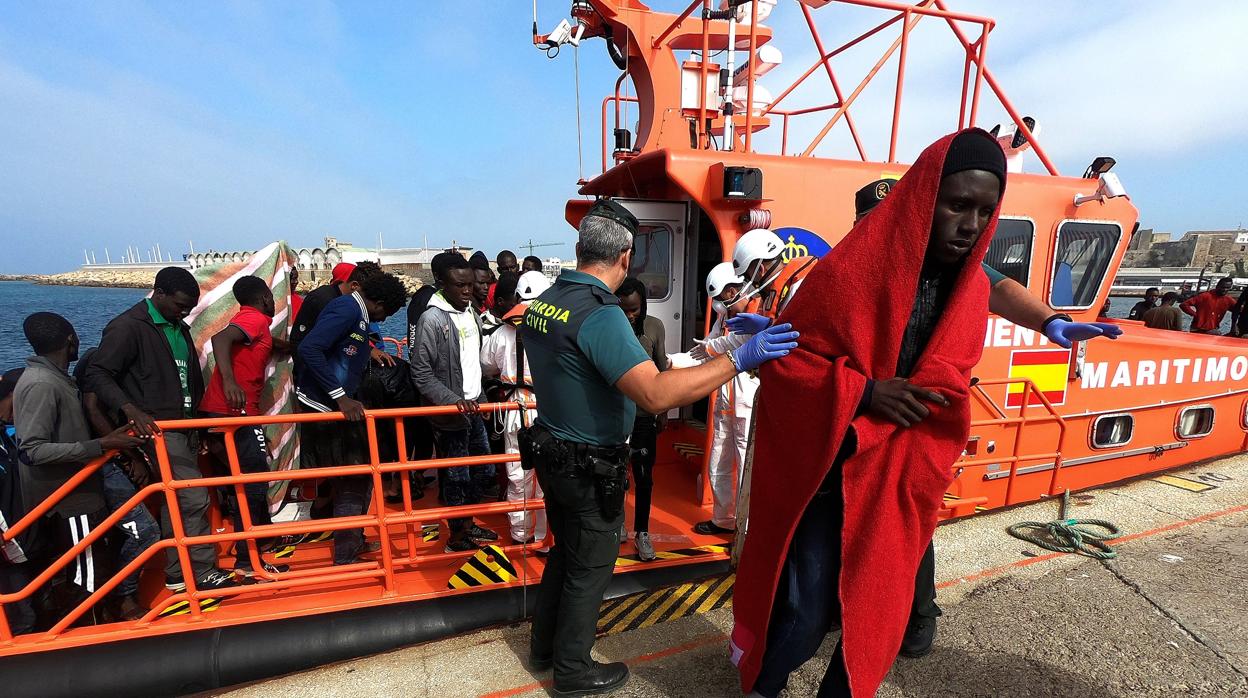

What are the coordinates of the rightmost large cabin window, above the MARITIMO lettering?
(1048, 221, 1122, 310)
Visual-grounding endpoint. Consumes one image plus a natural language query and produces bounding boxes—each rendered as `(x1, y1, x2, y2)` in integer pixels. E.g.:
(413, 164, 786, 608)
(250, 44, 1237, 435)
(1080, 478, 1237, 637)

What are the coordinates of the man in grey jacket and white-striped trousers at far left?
(12, 312, 142, 601)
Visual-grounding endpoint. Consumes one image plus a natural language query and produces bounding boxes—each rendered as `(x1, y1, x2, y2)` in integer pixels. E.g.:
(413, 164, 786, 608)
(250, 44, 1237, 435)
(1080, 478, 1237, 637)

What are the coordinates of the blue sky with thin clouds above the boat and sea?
(0, 0, 1248, 273)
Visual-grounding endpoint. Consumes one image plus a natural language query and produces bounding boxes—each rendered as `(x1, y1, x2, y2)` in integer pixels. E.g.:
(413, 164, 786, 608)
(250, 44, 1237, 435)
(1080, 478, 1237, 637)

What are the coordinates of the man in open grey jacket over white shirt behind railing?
(411, 257, 498, 552)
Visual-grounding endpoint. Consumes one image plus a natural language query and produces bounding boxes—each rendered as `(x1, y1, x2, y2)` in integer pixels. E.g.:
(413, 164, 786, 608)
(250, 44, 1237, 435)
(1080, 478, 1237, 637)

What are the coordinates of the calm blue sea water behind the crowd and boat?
(0, 281, 1231, 371)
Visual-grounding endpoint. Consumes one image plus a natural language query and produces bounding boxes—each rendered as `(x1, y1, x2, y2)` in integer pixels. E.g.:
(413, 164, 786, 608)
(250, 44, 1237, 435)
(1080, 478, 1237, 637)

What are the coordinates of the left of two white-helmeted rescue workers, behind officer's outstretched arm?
(694, 262, 759, 536)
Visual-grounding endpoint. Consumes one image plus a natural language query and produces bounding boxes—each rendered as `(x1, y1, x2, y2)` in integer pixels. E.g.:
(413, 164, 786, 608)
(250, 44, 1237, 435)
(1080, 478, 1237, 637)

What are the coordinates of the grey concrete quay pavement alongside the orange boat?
(217, 456, 1248, 698)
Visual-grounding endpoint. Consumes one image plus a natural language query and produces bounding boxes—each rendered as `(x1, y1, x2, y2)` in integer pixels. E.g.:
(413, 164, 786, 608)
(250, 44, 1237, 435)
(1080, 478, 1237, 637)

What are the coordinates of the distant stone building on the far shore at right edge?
(1122, 229, 1248, 276)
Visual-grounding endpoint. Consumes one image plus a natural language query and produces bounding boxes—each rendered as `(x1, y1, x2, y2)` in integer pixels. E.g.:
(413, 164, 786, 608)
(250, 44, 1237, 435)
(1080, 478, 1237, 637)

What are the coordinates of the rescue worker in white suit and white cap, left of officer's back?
(480, 271, 550, 552)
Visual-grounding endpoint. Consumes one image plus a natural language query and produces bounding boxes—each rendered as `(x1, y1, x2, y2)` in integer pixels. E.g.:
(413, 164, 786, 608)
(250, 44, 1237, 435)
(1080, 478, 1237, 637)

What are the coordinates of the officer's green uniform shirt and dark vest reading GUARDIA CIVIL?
(520, 271, 650, 446)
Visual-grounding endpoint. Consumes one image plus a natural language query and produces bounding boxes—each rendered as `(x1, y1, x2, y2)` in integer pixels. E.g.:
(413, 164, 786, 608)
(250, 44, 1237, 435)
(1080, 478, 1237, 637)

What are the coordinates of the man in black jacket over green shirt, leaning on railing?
(85, 267, 233, 592)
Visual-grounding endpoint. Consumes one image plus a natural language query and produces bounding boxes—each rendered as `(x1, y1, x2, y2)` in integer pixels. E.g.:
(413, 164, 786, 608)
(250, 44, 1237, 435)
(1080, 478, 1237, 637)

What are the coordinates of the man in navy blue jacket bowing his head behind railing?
(295, 272, 407, 564)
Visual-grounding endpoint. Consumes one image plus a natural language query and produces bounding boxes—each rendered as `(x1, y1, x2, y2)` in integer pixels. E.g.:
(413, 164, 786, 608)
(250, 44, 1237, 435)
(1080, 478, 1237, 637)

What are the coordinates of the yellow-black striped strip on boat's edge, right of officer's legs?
(598, 574, 736, 636)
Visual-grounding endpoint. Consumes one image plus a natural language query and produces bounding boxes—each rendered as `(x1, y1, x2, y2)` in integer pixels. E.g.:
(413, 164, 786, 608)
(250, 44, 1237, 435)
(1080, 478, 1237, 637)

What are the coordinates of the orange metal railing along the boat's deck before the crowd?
(0, 402, 543, 643)
